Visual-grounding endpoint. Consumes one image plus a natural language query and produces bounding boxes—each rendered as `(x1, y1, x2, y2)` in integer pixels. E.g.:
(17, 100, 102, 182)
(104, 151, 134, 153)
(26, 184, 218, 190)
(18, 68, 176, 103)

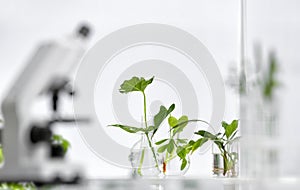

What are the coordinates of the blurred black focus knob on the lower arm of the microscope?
(30, 126, 52, 144)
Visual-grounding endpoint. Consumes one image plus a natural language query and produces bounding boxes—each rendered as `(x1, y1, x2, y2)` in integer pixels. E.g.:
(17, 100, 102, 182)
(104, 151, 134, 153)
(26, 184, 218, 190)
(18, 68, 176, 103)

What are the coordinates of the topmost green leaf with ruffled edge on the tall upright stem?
(119, 77, 154, 94)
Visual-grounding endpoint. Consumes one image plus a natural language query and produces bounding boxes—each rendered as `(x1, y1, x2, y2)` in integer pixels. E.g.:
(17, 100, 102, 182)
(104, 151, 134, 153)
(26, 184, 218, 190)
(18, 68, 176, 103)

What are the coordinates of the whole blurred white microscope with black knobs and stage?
(0, 25, 90, 184)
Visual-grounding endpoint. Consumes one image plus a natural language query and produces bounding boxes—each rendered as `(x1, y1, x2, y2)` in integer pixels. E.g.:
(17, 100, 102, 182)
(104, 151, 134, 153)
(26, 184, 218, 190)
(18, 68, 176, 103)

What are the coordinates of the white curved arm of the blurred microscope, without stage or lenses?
(0, 25, 91, 179)
